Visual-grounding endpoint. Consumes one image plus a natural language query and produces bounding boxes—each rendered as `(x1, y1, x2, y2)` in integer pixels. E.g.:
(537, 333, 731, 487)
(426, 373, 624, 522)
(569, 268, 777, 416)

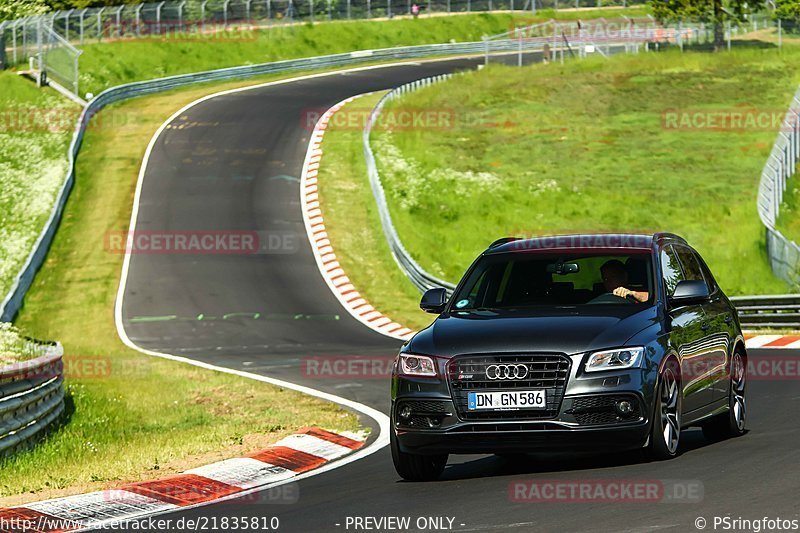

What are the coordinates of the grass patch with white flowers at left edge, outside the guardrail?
(0, 72, 78, 300)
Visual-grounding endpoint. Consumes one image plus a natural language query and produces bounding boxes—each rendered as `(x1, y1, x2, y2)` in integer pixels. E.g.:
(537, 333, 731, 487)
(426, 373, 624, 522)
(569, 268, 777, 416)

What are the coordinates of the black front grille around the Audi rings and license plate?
(448, 354, 570, 420)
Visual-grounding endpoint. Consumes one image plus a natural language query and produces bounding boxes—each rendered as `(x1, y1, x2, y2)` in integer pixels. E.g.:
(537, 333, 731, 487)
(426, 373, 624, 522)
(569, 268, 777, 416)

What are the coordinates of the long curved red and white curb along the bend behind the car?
(300, 95, 415, 340)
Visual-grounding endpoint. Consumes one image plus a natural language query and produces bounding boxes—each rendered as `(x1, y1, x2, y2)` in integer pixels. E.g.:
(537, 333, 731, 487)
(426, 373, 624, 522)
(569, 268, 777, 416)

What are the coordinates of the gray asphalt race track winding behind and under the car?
(122, 59, 800, 532)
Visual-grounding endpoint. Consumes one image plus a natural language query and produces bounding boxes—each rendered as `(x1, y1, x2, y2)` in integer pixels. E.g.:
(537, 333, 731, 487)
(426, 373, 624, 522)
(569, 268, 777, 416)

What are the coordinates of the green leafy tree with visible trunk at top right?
(652, 0, 764, 50)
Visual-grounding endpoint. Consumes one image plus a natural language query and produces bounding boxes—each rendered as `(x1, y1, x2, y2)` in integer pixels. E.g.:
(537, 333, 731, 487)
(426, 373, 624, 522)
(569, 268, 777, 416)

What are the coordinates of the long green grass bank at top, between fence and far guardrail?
(73, 8, 644, 94)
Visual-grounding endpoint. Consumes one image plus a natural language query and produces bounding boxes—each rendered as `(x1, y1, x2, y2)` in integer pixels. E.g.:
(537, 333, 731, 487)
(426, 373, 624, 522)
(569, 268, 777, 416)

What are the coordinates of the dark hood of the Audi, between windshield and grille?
(405, 306, 658, 357)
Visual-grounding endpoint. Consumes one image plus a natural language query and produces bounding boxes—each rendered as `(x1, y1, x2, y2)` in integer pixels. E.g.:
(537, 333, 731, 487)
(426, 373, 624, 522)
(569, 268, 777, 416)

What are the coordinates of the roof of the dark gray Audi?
(485, 232, 686, 254)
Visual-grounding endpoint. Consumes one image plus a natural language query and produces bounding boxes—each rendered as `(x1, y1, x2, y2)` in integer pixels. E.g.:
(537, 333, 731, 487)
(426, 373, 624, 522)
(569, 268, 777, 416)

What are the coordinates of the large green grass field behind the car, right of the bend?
(370, 46, 800, 298)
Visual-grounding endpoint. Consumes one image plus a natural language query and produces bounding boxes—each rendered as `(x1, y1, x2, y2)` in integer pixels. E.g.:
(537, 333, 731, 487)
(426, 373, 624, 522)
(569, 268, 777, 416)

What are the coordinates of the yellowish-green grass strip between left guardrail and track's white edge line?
(0, 72, 368, 506)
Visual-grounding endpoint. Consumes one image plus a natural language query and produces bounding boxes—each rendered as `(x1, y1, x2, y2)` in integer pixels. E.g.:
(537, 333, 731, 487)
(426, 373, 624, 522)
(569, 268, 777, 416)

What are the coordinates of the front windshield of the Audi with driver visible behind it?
(452, 250, 653, 311)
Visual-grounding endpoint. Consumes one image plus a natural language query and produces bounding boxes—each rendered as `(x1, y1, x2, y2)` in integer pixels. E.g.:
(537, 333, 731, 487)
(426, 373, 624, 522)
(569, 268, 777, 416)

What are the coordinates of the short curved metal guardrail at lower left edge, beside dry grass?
(0, 344, 64, 456)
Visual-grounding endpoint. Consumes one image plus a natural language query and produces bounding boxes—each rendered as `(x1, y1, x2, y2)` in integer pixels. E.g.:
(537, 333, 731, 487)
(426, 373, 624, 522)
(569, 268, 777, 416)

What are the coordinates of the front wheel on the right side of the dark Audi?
(645, 359, 683, 461)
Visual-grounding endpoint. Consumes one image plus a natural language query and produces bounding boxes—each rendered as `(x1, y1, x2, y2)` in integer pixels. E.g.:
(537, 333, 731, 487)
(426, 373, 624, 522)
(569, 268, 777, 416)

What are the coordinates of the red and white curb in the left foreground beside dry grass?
(0, 427, 366, 533)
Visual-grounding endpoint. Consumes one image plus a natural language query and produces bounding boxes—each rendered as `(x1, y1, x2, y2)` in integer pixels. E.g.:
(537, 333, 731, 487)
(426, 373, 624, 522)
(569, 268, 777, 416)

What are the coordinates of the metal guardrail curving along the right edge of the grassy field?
(757, 88, 800, 289)
